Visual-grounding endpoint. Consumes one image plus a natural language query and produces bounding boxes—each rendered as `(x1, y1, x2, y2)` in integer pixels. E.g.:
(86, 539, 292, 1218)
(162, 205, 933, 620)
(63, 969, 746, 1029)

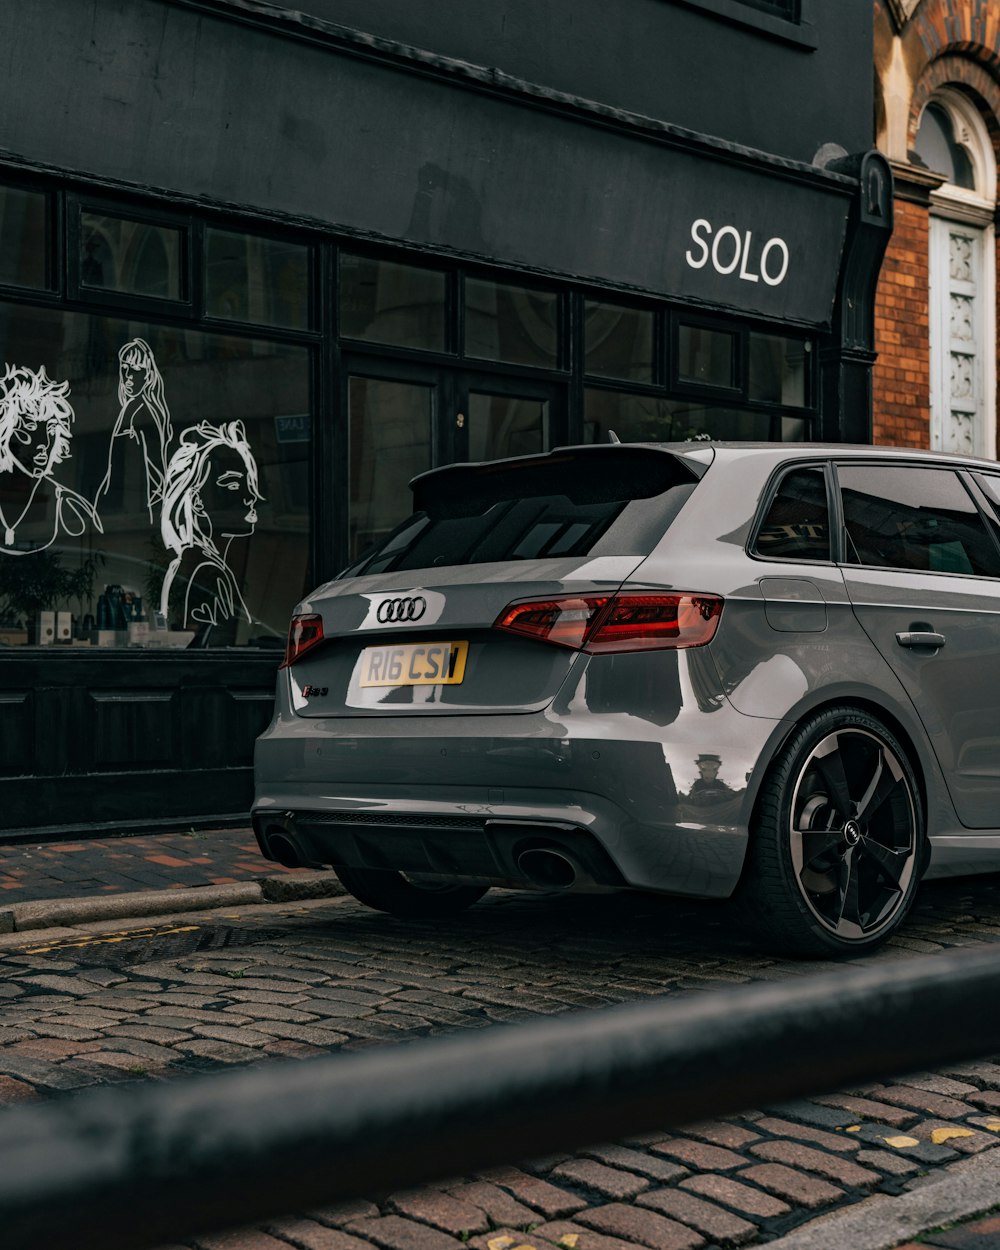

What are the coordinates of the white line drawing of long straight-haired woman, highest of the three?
(95, 339, 174, 521)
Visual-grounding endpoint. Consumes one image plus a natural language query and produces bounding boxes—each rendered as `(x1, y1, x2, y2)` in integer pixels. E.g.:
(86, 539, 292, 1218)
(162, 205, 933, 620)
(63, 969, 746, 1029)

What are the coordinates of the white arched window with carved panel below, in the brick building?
(916, 88, 996, 458)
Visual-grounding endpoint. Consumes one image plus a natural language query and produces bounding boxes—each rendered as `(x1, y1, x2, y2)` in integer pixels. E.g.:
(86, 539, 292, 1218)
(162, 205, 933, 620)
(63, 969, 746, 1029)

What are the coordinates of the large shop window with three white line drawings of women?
(0, 304, 310, 648)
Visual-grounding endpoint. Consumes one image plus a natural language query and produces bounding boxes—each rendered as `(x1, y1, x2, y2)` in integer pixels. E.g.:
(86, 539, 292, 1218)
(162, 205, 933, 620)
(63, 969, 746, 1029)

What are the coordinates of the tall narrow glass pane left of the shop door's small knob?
(348, 376, 434, 560)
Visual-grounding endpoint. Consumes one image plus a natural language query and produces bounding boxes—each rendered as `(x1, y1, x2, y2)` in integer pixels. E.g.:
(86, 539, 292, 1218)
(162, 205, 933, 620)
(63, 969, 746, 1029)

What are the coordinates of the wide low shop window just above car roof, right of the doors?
(584, 388, 773, 443)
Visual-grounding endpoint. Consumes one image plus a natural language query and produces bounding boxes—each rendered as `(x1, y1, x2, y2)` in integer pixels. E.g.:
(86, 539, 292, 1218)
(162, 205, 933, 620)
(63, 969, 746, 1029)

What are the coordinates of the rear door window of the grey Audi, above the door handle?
(838, 464, 1000, 578)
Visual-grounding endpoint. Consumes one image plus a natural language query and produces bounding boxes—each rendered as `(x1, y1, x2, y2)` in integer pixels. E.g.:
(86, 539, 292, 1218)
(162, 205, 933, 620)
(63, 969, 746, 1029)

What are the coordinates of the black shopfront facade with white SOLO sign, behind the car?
(0, 0, 891, 835)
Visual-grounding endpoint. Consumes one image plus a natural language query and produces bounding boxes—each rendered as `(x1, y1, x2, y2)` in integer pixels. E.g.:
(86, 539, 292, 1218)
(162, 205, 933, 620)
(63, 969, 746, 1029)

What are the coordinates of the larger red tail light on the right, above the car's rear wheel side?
(494, 590, 723, 655)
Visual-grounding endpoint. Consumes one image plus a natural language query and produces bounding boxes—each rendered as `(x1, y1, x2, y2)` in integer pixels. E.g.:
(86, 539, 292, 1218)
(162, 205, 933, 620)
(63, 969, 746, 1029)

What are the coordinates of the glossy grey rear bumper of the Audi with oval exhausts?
(254, 703, 778, 898)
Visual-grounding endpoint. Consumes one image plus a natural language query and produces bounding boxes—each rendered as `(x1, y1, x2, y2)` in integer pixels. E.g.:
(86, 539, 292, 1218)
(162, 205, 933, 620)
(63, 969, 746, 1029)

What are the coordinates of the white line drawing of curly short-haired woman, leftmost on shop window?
(0, 365, 103, 555)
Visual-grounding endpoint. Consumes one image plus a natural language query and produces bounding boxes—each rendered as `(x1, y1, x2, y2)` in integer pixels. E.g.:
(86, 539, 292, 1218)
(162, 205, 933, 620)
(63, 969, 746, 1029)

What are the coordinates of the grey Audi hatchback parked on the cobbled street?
(253, 443, 1000, 955)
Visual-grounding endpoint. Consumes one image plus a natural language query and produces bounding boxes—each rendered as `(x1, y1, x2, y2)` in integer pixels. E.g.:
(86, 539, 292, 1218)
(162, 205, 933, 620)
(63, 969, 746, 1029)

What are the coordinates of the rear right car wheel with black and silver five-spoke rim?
(738, 708, 924, 958)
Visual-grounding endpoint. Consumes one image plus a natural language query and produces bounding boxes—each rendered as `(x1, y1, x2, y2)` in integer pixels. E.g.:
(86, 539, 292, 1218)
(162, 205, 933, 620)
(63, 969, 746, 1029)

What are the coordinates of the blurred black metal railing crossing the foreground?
(0, 945, 1000, 1250)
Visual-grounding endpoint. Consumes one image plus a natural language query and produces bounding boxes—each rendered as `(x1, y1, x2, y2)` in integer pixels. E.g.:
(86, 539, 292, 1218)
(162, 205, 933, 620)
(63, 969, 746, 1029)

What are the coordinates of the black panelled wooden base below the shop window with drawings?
(0, 635, 280, 833)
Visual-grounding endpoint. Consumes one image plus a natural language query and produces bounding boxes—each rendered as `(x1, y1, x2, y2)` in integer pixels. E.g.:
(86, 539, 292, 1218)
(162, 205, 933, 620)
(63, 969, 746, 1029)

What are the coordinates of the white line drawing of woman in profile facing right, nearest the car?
(160, 421, 264, 628)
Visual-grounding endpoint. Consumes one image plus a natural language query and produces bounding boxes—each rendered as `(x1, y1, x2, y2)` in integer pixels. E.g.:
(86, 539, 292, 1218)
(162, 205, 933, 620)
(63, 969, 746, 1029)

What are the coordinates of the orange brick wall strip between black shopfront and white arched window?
(873, 200, 930, 448)
